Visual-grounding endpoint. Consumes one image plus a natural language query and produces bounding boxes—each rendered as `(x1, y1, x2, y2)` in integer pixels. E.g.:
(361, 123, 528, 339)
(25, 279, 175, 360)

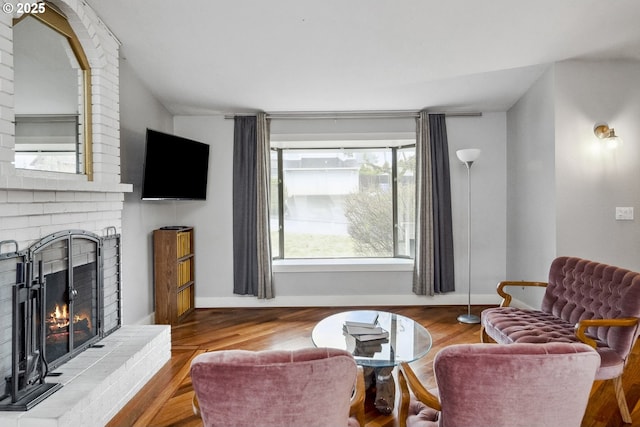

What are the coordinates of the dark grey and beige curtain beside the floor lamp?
(413, 111, 455, 295)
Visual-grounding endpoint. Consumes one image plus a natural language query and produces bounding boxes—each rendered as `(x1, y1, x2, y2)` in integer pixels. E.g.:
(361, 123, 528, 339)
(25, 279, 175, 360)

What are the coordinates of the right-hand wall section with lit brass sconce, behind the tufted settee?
(555, 61, 640, 271)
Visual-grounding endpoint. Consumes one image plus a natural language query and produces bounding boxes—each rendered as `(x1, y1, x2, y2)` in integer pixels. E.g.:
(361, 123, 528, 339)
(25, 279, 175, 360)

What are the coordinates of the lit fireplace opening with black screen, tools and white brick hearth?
(0, 228, 171, 427)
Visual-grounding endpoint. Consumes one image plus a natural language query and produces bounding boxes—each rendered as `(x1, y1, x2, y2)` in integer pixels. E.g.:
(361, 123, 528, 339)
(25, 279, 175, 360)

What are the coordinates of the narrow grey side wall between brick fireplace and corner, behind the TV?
(120, 59, 176, 324)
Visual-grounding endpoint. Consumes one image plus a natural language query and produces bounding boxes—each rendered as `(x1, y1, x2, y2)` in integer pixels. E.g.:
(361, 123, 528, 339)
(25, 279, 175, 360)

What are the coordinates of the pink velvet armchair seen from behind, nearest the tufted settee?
(398, 343, 600, 427)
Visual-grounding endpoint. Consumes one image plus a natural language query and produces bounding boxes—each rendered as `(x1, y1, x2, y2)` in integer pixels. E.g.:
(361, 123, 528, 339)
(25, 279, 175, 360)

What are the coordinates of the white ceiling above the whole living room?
(87, 0, 640, 115)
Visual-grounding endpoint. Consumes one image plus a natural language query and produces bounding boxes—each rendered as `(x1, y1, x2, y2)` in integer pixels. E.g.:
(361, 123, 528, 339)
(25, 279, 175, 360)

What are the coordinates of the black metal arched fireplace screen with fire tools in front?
(0, 229, 121, 410)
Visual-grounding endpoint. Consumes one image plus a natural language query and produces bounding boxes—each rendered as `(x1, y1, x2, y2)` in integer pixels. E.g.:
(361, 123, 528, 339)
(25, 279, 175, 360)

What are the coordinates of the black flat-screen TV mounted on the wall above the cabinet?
(142, 129, 209, 200)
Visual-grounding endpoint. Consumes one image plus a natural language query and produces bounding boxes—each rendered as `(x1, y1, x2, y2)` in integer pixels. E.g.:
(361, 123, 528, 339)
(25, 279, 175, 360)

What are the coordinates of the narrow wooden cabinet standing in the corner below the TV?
(153, 227, 196, 325)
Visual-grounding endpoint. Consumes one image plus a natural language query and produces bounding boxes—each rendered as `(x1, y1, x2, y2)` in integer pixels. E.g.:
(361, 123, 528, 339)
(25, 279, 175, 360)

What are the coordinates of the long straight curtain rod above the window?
(224, 111, 482, 120)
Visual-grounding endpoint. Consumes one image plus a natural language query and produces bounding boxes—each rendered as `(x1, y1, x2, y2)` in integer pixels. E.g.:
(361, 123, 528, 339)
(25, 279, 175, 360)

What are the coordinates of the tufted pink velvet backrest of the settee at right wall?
(541, 257, 640, 358)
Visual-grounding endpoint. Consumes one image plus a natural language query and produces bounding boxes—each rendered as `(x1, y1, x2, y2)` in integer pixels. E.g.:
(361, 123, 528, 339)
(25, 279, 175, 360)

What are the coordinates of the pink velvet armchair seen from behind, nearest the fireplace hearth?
(191, 348, 365, 427)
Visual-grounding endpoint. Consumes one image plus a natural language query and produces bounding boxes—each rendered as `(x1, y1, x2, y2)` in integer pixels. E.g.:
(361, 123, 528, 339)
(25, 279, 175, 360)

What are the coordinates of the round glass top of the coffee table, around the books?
(311, 310, 431, 368)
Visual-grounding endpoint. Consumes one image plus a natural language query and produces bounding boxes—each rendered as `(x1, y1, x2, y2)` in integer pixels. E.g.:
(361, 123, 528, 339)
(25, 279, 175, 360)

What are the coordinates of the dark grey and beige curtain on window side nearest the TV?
(233, 114, 274, 298)
